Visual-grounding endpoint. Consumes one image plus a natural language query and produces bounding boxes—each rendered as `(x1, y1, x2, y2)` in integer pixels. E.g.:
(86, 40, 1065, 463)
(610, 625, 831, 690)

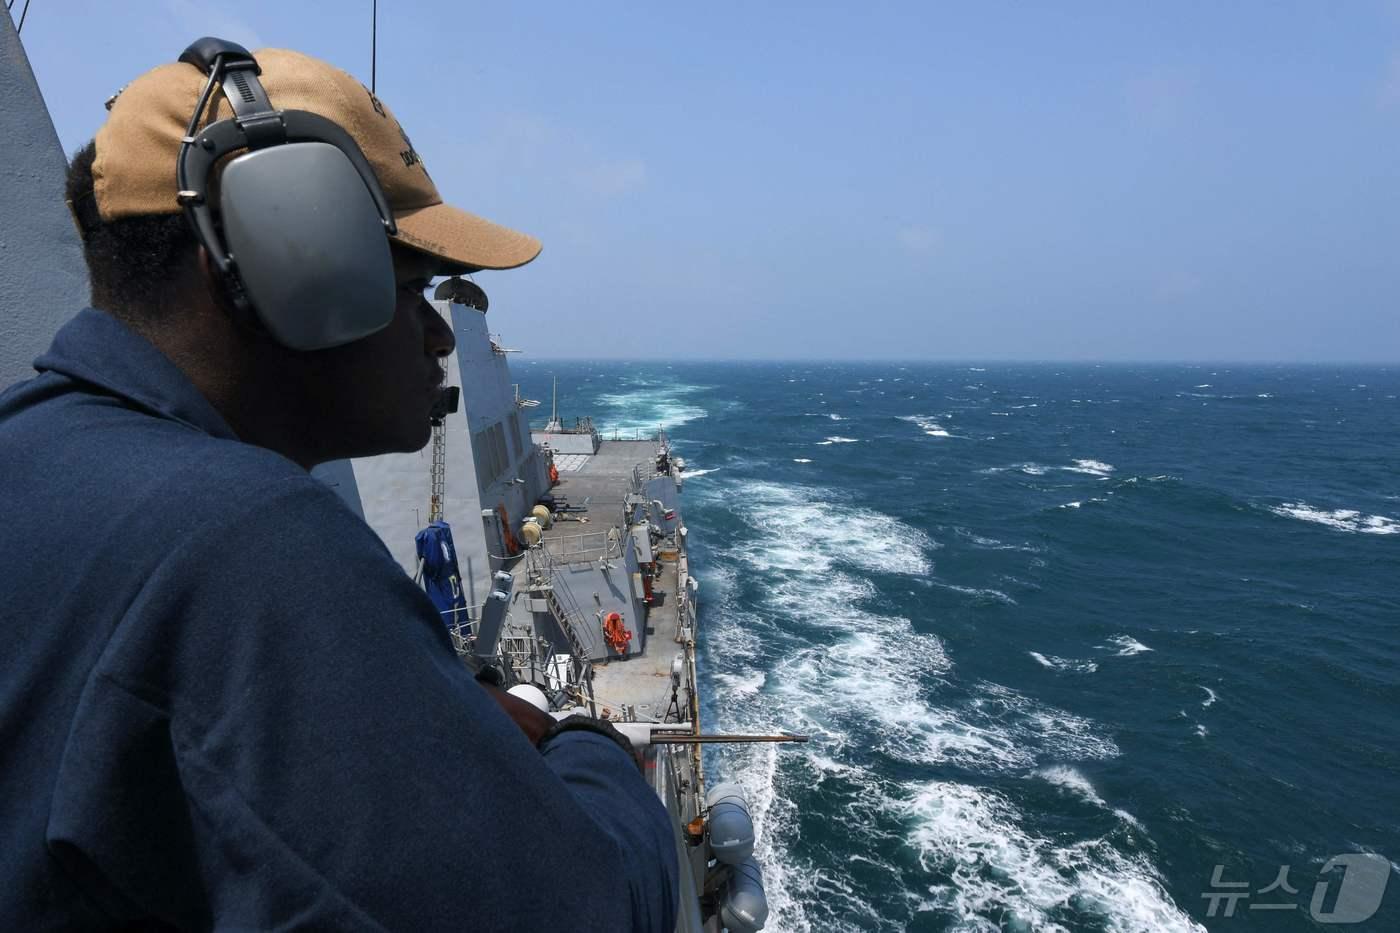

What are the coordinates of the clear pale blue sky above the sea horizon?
(14, 0, 1400, 361)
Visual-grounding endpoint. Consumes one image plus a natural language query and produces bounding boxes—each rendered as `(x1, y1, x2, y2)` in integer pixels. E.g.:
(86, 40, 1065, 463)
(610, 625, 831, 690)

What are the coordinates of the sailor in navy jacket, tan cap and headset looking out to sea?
(0, 39, 678, 932)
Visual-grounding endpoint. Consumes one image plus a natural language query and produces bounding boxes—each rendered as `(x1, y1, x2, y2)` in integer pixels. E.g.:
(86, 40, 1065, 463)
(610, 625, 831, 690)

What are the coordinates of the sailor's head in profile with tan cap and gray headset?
(67, 39, 540, 465)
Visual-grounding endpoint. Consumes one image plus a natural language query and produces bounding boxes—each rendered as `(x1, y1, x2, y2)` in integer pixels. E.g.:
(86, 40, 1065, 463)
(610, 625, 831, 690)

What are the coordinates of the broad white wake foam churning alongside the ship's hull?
(701, 482, 1198, 933)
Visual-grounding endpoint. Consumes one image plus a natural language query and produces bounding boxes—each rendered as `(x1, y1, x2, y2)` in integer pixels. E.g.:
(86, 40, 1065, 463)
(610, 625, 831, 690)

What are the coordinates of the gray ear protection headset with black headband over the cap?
(176, 36, 396, 350)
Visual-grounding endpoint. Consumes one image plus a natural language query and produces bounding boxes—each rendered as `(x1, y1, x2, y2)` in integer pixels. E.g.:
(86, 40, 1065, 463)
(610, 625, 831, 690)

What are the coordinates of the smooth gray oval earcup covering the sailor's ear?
(218, 143, 395, 350)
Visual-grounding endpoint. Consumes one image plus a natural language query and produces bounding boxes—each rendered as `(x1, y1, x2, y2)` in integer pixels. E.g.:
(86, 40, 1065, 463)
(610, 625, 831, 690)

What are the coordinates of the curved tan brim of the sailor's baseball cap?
(391, 205, 540, 275)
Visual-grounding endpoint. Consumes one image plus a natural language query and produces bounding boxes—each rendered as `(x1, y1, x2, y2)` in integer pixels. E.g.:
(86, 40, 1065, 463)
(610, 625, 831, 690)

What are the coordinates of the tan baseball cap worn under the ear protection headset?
(92, 49, 540, 273)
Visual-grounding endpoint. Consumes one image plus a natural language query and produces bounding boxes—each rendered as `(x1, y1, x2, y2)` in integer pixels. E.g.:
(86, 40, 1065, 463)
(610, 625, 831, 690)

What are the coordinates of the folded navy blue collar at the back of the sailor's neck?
(34, 308, 238, 440)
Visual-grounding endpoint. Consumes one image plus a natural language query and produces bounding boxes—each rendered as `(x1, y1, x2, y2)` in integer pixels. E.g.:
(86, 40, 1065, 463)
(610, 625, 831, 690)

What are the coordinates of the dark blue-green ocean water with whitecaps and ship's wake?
(515, 360, 1400, 933)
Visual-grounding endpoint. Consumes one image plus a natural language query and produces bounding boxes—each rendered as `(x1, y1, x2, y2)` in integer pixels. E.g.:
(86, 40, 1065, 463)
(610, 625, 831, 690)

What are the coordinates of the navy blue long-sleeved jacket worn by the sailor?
(0, 310, 676, 932)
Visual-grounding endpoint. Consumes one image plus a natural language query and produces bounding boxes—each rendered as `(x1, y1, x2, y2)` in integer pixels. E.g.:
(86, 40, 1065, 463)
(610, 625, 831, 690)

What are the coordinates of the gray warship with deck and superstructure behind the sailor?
(0, 17, 804, 933)
